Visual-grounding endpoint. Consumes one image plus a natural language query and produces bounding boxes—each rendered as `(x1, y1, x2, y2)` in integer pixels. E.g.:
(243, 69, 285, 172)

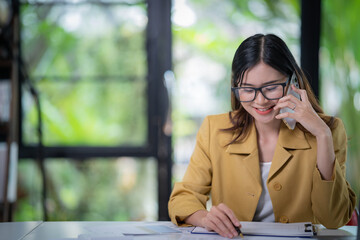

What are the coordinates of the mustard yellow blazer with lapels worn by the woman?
(168, 113, 356, 228)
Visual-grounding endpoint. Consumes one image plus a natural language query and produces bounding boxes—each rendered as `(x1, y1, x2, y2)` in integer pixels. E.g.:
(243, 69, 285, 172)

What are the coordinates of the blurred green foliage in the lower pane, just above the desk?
(15, 158, 157, 221)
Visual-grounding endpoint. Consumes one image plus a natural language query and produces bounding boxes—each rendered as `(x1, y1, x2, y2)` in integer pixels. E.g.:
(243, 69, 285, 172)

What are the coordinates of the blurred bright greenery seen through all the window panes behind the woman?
(15, 0, 360, 221)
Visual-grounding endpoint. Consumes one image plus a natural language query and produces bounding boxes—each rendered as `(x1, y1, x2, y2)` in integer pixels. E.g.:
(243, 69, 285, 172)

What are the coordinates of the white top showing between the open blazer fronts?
(253, 162, 275, 222)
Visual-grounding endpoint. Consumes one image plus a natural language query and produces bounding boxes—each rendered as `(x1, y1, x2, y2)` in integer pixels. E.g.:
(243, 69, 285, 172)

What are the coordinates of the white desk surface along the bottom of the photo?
(0, 222, 357, 240)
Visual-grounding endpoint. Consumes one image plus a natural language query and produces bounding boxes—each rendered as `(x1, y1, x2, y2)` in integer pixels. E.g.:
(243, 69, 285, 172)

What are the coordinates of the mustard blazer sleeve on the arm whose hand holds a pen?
(168, 117, 212, 225)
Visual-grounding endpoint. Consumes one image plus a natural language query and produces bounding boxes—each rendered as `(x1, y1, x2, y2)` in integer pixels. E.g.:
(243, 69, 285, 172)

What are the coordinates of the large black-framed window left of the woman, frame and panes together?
(16, 0, 171, 220)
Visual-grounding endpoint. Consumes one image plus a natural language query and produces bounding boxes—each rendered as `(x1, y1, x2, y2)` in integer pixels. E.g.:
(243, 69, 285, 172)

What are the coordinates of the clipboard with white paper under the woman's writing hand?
(191, 222, 316, 237)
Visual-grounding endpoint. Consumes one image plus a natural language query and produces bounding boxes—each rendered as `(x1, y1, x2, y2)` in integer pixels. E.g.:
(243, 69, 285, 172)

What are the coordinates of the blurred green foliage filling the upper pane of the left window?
(22, 3, 147, 146)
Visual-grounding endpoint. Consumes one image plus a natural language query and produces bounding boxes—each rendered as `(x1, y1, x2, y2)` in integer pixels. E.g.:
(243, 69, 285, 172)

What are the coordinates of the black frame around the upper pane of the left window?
(14, 0, 172, 220)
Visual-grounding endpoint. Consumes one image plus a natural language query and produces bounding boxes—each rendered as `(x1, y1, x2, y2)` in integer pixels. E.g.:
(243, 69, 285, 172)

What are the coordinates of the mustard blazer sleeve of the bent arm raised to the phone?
(311, 118, 356, 228)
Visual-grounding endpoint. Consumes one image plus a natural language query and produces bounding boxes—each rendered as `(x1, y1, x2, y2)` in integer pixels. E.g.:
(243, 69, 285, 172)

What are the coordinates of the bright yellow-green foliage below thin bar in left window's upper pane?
(24, 79, 147, 146)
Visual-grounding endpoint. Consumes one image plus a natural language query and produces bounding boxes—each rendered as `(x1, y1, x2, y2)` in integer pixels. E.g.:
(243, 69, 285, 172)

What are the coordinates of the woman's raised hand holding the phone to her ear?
(274, 85, 330, 137)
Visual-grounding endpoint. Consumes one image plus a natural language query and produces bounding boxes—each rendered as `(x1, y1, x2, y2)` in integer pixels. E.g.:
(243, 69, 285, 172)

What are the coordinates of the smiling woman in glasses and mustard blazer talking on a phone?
(169, 34, 356, 238)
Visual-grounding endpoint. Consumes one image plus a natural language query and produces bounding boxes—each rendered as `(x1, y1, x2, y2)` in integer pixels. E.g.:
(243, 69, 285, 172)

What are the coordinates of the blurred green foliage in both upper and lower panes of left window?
(15, 4, 157, 221)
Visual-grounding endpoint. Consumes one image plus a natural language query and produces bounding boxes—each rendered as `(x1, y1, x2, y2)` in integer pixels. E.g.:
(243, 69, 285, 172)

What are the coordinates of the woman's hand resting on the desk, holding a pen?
(201, 203, 241, 238)
